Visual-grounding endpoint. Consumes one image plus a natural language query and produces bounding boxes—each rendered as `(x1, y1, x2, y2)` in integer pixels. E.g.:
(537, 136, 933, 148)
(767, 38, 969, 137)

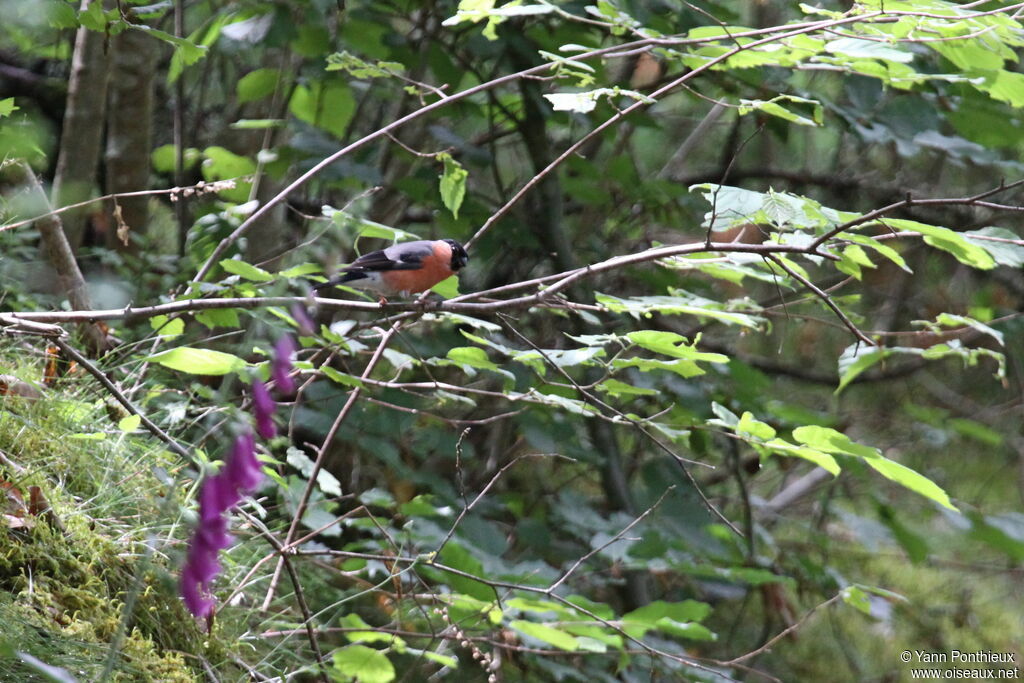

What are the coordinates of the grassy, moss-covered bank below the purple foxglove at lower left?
(0, 349, 239, 682)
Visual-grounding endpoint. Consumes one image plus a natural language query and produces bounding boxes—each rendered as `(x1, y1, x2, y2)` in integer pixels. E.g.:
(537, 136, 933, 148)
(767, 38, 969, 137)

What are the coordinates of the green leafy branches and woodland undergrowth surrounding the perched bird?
(0, 0, 1024, 683)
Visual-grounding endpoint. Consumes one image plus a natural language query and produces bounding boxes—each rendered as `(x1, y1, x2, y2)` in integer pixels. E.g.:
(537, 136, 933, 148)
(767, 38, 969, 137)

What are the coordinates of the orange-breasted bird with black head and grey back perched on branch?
(314, 240, 469, 297)
